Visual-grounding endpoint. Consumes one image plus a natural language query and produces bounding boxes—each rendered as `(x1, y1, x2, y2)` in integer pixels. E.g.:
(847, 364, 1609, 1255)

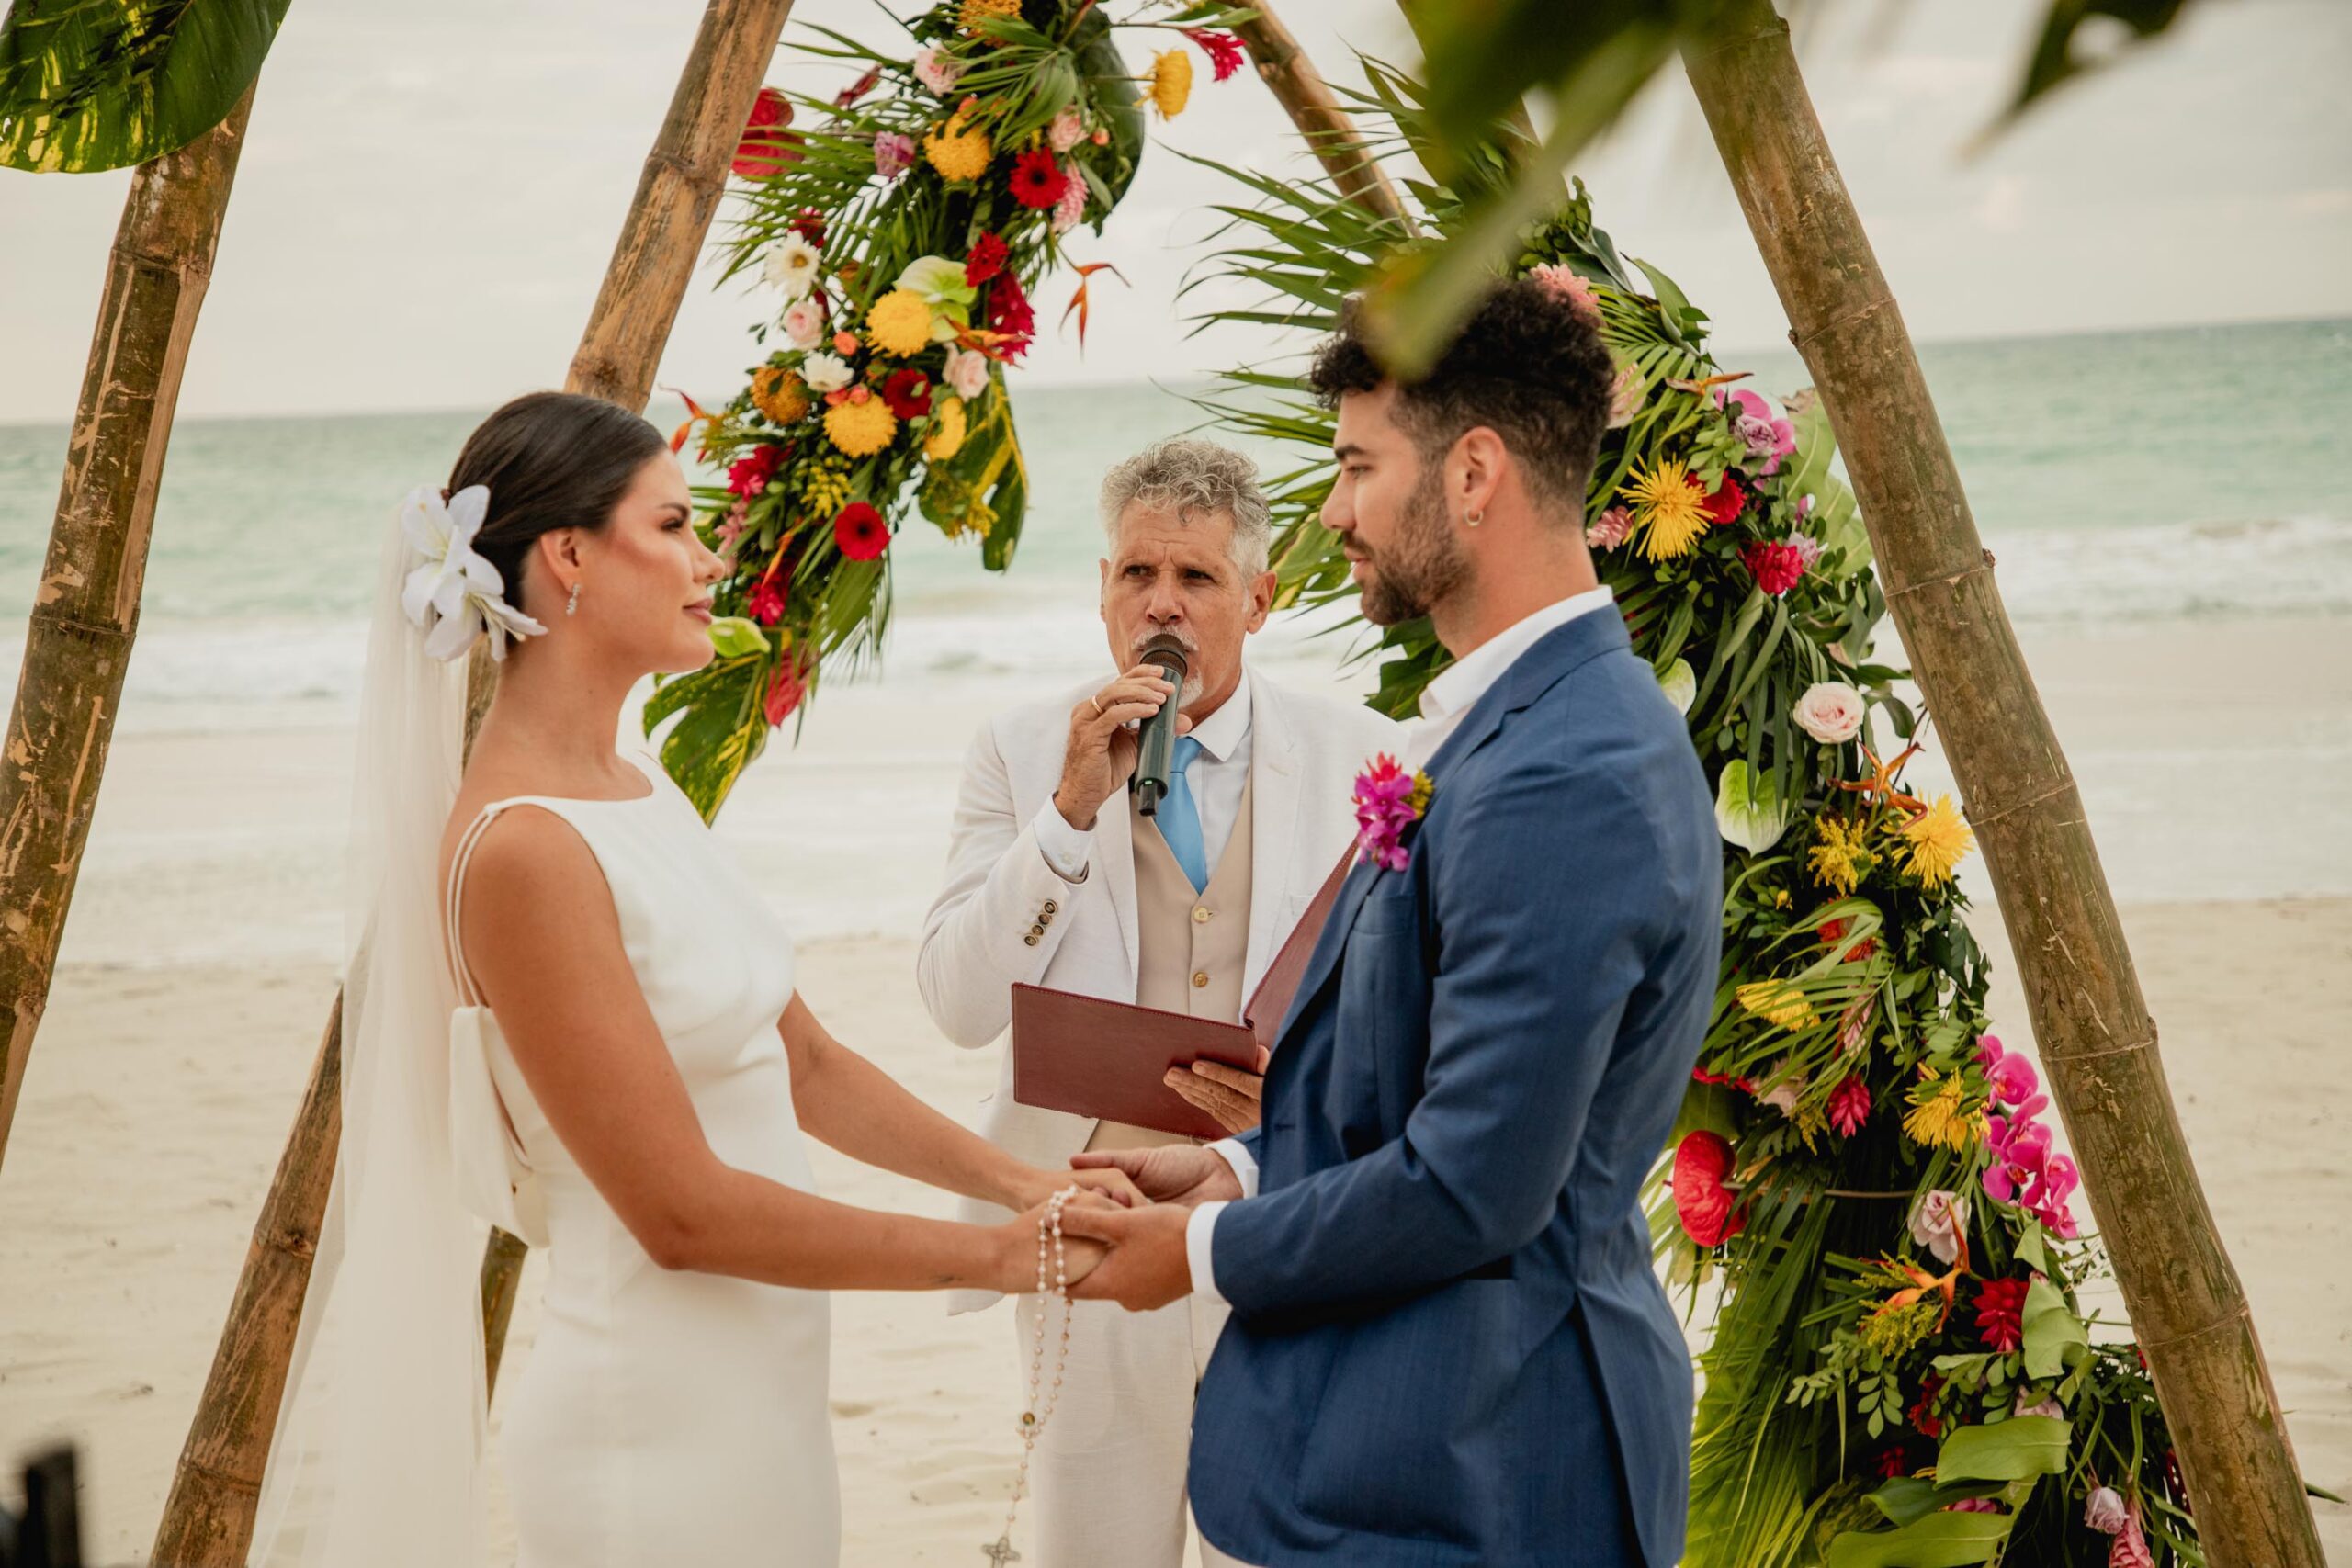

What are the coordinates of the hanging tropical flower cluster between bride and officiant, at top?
(644, 0, 1242, 816)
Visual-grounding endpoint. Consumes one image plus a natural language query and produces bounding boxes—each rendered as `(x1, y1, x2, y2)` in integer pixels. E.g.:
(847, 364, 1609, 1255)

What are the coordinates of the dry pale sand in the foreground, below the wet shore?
(0, 900, 2352, 1568)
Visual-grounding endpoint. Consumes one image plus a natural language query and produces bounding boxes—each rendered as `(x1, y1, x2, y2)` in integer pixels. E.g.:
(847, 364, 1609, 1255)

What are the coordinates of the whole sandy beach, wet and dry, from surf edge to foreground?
(0, 618, 2352, 1568)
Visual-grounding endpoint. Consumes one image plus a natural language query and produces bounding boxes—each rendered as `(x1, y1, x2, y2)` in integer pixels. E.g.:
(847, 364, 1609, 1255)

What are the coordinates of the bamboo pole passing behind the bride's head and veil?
(151, 0, 793, 1568)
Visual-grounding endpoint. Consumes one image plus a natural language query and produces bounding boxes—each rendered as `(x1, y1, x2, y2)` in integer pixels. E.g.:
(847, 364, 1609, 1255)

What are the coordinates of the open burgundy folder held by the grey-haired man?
(1013, 849, 1355, 1138)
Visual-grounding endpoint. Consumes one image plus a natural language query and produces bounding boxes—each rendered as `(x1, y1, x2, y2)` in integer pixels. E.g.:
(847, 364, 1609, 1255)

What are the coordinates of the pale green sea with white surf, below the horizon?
(0, 320, 2352, 733)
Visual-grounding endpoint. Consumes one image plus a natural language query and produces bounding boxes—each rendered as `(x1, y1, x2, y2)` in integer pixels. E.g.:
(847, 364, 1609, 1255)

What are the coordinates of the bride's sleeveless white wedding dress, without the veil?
(452, 755, 840, 1568)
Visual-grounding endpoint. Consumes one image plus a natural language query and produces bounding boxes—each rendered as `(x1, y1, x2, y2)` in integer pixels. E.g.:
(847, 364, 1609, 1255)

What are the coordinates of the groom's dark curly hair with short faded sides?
(1307, 277, 1616, 522)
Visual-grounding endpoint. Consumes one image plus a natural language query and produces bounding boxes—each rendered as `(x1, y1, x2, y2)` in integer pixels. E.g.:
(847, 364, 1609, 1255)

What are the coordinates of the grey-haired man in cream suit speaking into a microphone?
(917, 440, 1397, 1568)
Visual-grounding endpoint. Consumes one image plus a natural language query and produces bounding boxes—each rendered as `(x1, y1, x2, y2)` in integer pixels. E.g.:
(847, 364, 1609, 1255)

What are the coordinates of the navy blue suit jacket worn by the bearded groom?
(1190, 609, 1722, 1568)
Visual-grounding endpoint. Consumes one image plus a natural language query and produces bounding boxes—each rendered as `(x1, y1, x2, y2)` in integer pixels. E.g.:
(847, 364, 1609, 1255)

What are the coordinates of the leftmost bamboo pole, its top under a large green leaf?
(0, 87, 254, 1175)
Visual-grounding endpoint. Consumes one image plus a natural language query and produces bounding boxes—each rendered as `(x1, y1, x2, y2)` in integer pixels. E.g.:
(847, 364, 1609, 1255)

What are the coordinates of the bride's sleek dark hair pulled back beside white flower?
(447, 392, 668, 609)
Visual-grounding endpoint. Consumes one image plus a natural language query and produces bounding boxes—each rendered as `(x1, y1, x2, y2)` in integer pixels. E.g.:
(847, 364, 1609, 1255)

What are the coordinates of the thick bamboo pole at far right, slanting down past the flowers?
(1684, 0, 2322, 1568)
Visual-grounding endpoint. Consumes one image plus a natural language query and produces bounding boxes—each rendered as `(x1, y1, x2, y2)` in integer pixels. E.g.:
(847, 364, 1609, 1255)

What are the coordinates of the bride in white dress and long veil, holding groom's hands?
(252, 392, 1141, 1568)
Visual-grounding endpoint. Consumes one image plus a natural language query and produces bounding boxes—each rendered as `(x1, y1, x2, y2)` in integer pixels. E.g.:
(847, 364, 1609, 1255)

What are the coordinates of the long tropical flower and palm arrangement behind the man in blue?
(1202, 62, 2204, 1568)
